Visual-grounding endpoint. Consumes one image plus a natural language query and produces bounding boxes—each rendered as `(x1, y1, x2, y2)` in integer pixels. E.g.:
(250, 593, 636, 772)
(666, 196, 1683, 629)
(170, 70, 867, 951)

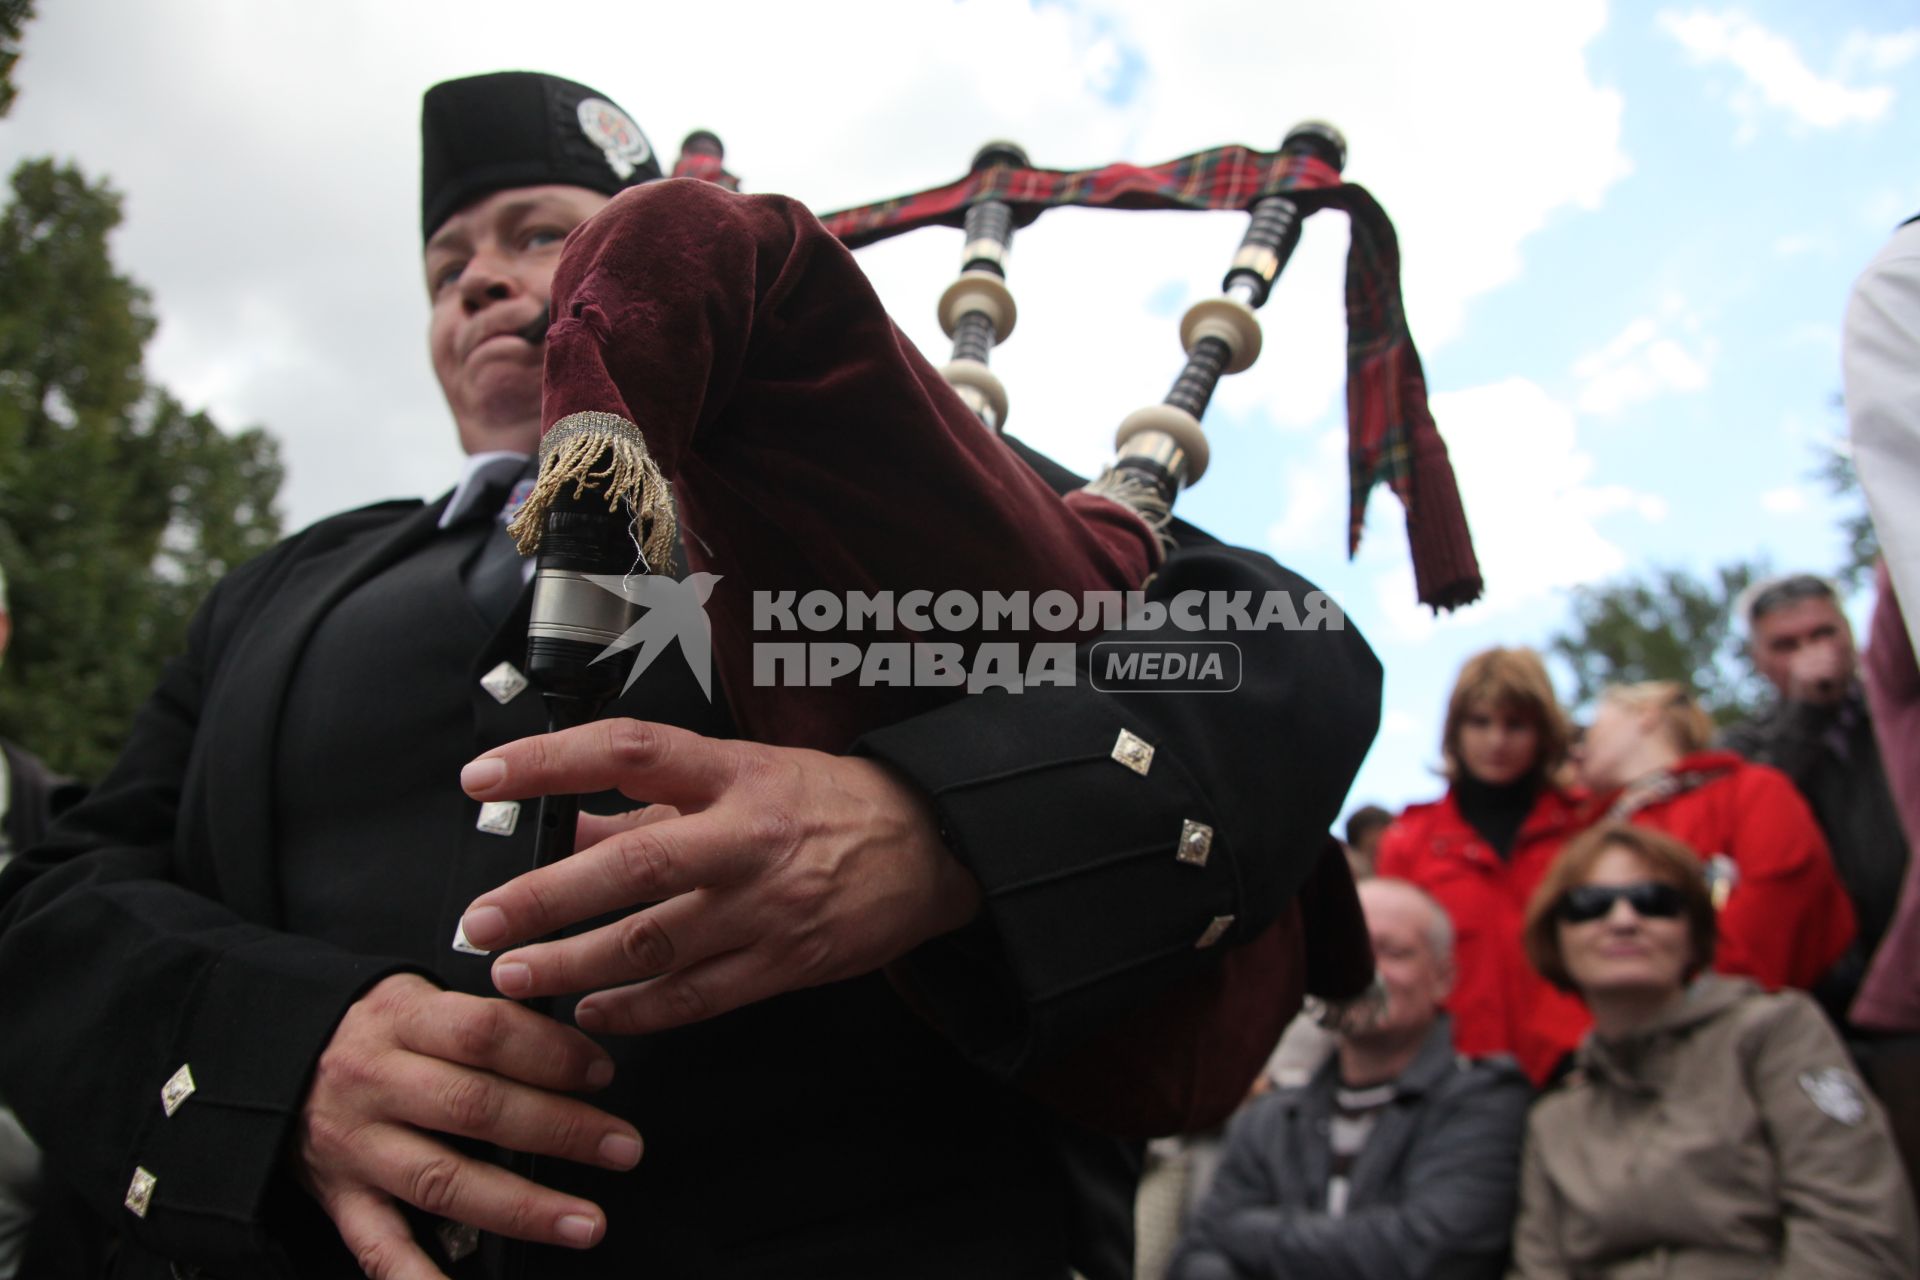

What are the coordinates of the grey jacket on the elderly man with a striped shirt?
(1167, 1015, 1532, 1280)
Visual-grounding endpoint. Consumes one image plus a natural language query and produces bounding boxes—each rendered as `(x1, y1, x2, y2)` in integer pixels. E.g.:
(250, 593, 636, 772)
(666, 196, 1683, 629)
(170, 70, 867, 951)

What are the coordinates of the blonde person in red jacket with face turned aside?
(1580, 679, 1853, 988)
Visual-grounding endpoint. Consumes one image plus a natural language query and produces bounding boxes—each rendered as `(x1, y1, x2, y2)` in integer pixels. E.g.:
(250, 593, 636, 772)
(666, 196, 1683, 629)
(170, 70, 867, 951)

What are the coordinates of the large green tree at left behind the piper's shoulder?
(0, 159, 280, 777)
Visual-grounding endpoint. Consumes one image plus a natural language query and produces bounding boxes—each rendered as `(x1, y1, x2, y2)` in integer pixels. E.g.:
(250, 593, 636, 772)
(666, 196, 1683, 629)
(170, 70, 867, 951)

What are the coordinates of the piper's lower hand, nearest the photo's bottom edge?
(292, 973, 639, 1280)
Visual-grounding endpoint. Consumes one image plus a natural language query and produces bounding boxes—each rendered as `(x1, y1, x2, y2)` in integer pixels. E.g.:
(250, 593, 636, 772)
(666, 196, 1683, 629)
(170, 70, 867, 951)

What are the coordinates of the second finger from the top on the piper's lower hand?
(369, 1054, 639, 1169)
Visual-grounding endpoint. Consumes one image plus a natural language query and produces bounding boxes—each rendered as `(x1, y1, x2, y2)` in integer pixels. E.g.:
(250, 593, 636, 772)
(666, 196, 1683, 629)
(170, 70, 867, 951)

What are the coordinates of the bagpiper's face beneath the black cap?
(426, 186, 607, 453)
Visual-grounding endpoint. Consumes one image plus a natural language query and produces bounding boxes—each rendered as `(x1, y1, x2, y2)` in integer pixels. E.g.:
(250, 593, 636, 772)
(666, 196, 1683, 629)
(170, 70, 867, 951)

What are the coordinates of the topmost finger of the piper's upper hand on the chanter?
(461, 720, 744, 808)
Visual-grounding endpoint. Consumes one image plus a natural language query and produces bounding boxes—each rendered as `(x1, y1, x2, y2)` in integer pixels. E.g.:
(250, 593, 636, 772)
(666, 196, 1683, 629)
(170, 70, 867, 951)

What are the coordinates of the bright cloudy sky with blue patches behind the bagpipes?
(0, 0, 1920, 821)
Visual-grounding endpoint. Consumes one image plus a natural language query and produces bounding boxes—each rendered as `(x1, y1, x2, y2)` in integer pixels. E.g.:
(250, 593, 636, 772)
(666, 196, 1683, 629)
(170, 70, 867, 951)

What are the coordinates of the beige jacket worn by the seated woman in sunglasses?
(1509, 975, 1920, 1280)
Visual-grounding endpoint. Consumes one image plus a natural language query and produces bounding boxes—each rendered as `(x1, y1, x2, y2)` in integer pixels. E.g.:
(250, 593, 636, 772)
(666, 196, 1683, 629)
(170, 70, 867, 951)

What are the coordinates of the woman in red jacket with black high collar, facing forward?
(1379, 649, 1588, 1084)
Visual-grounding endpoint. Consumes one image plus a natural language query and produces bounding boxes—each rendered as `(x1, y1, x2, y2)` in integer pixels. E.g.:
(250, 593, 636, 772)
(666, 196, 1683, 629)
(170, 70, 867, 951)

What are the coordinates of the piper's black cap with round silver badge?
(420, 71, 660, 240)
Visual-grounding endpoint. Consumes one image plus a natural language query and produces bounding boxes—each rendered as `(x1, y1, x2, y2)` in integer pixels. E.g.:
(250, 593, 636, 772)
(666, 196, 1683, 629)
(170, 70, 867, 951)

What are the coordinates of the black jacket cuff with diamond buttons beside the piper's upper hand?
(858, 687, 1263, 1075)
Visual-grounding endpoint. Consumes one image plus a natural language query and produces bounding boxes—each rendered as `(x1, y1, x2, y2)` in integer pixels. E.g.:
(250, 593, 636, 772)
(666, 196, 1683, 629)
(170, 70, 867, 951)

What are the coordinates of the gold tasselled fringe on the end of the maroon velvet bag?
(507, 413, 680, 574)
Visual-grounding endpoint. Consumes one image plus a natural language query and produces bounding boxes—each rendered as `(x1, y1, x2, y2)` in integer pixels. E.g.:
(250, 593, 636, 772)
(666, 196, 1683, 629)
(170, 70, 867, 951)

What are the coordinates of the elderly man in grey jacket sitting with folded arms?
(1167, 879, 1532, 1280)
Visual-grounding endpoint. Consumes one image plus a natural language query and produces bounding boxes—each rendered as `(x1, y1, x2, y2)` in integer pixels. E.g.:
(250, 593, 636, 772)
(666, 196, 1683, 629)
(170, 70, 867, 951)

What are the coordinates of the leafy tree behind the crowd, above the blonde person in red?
(1548, 564, 1763, 725)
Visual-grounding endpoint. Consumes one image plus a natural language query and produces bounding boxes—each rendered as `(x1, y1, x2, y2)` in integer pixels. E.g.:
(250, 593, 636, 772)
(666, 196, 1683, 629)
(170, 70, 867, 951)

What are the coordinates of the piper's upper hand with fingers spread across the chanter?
(461, 720, 979, 1032)
